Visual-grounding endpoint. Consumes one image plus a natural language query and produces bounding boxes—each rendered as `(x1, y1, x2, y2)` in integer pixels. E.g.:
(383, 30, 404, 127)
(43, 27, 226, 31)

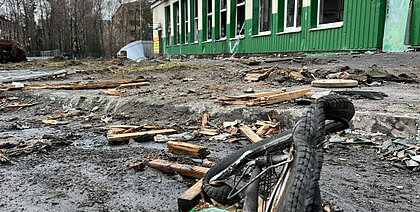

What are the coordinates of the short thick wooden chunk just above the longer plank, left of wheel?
(166, 141, 208, 158)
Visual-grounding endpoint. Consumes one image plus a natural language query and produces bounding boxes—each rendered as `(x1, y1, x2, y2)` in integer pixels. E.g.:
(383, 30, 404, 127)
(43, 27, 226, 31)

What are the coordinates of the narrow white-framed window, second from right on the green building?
(284, 0, 302, 32)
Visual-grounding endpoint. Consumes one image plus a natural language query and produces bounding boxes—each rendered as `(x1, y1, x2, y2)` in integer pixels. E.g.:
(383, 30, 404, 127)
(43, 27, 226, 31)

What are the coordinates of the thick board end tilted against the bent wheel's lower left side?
(178, 179, 203, 212)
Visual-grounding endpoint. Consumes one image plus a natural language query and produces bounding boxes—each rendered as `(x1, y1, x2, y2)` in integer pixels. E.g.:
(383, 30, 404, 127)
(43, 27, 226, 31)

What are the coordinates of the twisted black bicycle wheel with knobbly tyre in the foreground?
(203, 95, 354, 208)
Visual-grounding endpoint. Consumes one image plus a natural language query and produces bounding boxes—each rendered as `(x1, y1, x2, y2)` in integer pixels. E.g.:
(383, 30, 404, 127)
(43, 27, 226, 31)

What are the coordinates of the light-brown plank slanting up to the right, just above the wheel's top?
(247, 89, 311, 106)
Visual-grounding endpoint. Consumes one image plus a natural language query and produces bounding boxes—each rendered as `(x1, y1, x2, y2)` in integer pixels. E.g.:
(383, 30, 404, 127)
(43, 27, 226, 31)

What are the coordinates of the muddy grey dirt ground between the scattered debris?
(0, 52, 420, 211)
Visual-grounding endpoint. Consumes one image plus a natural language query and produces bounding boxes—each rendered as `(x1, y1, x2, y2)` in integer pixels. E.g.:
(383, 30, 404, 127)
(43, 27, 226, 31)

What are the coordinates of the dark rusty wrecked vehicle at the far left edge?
(0, 40, 27, 63)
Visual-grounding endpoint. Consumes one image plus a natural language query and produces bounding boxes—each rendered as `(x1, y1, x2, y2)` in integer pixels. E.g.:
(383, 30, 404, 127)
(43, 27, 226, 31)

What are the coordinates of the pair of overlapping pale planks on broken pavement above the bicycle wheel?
(218, 89, 313, 106)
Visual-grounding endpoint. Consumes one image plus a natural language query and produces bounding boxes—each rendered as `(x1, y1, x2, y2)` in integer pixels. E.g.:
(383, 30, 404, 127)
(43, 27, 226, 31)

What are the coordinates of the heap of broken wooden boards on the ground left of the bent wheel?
(110, 113, 284, 211)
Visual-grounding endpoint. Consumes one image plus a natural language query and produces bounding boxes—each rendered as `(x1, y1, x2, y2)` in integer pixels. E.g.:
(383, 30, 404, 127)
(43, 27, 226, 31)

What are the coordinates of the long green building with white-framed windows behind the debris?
(152, 0, 420, 55)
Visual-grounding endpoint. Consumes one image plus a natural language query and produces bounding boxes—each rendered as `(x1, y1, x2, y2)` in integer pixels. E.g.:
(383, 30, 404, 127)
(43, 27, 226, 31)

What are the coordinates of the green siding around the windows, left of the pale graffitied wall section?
(164, 0, 386, 54)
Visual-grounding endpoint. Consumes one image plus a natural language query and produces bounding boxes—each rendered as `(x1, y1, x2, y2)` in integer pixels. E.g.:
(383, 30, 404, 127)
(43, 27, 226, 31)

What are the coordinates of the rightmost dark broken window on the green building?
(318, 0, 344, 25)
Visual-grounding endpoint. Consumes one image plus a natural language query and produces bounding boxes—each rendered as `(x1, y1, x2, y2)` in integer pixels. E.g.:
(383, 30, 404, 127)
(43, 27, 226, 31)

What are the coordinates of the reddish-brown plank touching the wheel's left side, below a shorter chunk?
(149, 159, 209, 179)
